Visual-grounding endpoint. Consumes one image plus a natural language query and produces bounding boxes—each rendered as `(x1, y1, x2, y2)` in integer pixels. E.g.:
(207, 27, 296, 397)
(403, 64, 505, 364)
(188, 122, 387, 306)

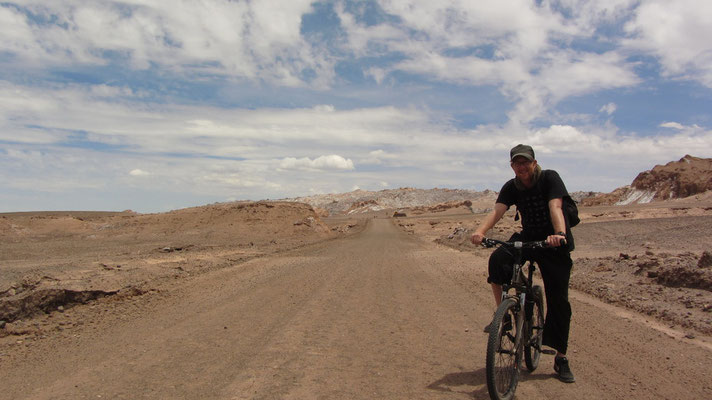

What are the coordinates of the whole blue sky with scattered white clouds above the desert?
(0, 0, 712, 213)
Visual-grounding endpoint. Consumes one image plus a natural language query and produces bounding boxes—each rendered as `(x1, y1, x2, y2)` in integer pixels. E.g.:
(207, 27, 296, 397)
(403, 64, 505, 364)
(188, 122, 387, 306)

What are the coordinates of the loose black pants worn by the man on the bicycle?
(487, 234, 573, 354)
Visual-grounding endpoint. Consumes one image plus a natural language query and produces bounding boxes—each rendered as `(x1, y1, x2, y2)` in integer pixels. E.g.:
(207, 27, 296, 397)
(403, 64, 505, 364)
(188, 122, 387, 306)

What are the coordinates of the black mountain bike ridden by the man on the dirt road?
(482, 238, 555, 400)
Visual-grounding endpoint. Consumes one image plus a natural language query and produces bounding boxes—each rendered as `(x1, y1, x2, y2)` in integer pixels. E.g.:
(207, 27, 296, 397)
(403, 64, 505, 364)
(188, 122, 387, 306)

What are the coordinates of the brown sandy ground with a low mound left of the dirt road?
(0, 202, 359, 324)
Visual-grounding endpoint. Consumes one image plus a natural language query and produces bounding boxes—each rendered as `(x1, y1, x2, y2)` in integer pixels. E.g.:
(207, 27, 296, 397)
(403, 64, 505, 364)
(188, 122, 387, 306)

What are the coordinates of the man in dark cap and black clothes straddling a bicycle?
(471, 144, 574, 383)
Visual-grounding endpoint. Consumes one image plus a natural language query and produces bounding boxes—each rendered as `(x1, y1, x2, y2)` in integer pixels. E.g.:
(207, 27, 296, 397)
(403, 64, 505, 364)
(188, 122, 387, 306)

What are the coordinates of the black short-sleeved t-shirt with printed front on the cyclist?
(497, 170, 569, 240)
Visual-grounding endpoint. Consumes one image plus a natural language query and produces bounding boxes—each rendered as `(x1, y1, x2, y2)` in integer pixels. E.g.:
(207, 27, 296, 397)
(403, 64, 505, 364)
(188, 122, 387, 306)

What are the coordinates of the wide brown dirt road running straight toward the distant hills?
(0, 219, 712, 399)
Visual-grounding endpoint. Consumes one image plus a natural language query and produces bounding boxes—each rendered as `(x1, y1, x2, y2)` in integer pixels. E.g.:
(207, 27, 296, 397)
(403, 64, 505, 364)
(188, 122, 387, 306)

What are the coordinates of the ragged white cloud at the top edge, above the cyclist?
(339, 0, 640, 125)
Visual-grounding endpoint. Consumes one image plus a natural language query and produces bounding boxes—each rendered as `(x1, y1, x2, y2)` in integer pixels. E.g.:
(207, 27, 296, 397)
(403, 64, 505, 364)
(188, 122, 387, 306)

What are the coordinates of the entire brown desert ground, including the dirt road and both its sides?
(0, 196, 712, 399)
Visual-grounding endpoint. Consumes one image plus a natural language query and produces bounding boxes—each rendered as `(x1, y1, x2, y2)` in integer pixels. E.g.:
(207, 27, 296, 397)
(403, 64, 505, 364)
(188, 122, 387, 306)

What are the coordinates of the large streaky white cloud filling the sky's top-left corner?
(0, 0, 326, 86)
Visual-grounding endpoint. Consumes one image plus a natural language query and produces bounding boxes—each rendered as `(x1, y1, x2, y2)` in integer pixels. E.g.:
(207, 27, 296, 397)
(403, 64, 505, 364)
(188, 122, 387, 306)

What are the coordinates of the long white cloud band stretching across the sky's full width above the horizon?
(0, 77, 712, 205)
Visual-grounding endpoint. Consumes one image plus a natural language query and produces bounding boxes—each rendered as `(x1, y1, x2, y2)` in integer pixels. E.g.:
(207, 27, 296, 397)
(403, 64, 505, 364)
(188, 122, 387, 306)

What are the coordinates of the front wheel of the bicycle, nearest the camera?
(485, 299, 521, 400)
